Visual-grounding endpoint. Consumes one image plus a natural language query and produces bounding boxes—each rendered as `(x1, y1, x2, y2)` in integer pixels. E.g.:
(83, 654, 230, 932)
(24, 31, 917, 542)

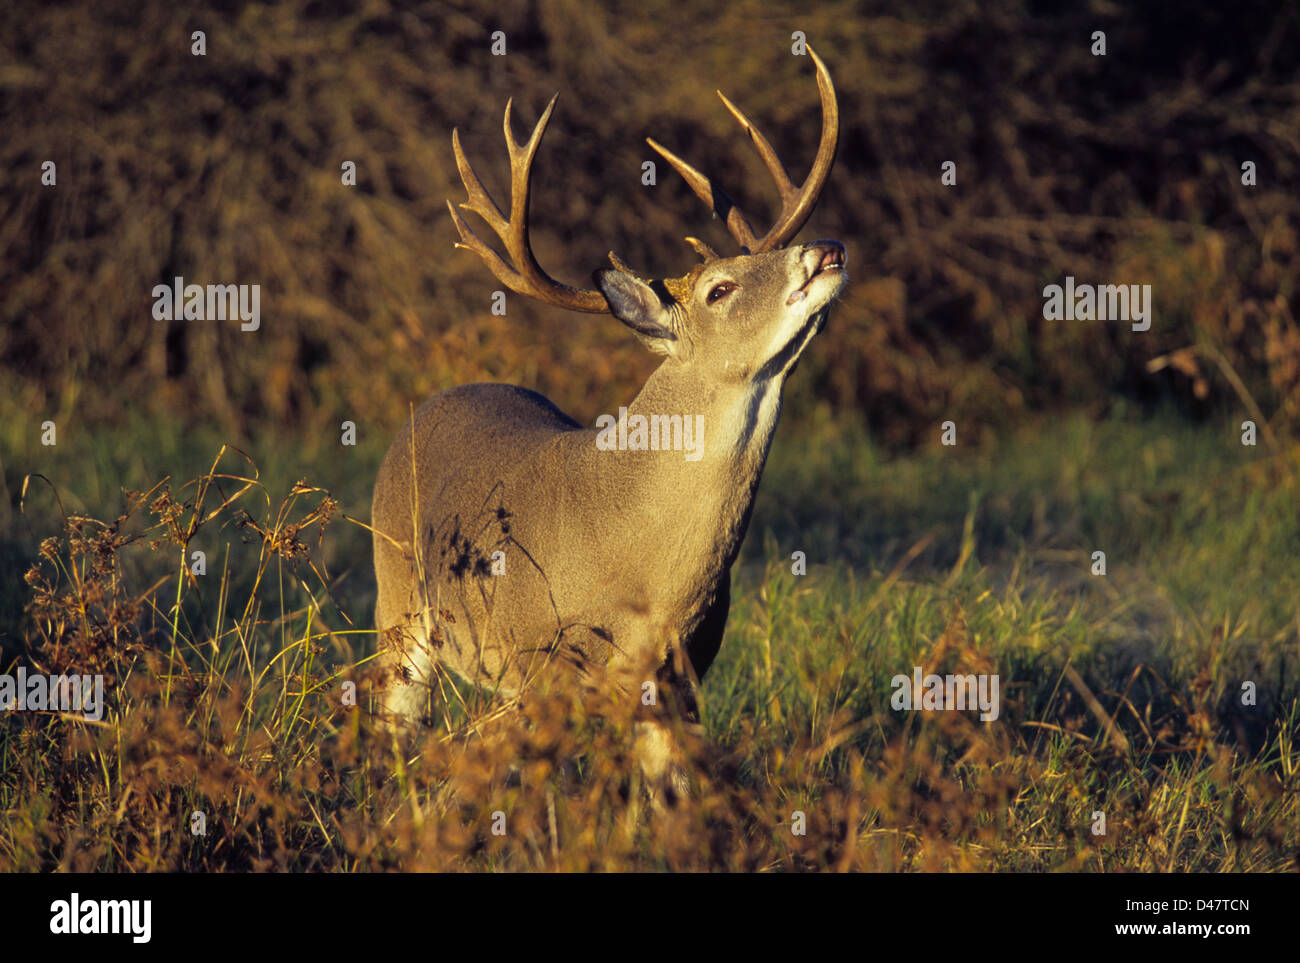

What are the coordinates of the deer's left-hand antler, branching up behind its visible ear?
(447, 94, 610, 315)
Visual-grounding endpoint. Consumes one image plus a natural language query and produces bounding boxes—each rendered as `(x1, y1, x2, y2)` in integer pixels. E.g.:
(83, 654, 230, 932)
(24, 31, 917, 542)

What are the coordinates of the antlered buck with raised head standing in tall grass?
(372, 48, 846, 791)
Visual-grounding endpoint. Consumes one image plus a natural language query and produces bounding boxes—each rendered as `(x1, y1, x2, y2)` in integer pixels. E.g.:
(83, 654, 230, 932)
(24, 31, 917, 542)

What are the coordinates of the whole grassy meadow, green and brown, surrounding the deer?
(0, 413, 1300, 872)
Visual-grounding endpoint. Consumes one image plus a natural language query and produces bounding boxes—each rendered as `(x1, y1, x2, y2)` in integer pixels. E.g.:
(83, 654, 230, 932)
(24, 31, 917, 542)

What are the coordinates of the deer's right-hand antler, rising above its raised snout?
(646, 47, 840, 255)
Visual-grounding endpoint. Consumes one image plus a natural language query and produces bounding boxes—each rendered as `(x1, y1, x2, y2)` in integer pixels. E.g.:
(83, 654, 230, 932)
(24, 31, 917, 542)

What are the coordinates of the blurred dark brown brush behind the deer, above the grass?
(0, 0, 1300, 446)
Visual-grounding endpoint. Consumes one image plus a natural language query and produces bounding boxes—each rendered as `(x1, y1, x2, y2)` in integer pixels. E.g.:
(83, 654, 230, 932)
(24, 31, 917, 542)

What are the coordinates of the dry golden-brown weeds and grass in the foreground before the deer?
(0, 452, 1300, 872)
